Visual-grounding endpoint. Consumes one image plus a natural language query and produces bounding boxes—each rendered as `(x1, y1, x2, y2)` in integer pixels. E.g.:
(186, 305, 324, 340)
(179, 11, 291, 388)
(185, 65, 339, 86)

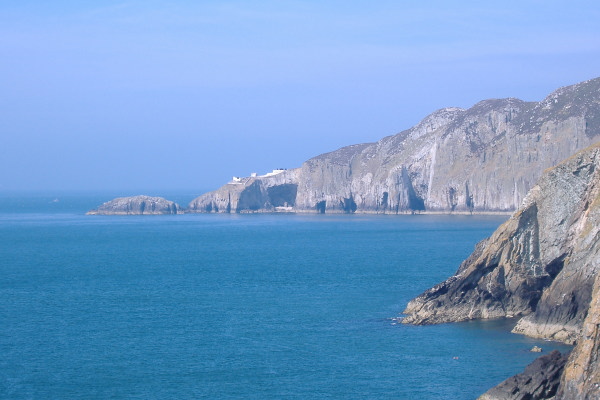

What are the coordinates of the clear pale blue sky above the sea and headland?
(0, 0, 600, 194)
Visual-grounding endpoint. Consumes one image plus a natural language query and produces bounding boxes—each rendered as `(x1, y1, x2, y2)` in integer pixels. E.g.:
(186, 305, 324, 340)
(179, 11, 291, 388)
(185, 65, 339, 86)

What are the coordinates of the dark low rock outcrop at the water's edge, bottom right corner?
(478, 350, 568, 400)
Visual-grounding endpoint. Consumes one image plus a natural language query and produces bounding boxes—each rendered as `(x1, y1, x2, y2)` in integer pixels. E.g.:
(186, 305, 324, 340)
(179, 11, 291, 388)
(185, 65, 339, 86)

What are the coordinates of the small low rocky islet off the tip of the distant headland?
(87, 196, 181, 215)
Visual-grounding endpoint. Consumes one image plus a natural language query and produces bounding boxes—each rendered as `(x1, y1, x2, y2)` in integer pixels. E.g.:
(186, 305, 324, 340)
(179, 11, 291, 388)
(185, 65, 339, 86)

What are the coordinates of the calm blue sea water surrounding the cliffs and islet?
(0, 194, 568, 399)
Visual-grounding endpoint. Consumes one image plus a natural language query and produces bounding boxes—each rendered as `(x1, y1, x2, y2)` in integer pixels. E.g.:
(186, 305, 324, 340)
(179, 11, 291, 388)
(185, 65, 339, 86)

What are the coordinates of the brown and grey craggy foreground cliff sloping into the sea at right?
(403, 143, 600, 399)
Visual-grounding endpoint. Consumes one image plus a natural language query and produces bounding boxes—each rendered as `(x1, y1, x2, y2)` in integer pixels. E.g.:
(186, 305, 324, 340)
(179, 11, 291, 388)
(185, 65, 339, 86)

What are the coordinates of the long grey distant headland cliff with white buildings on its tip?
(190, 78, 600, 213)
